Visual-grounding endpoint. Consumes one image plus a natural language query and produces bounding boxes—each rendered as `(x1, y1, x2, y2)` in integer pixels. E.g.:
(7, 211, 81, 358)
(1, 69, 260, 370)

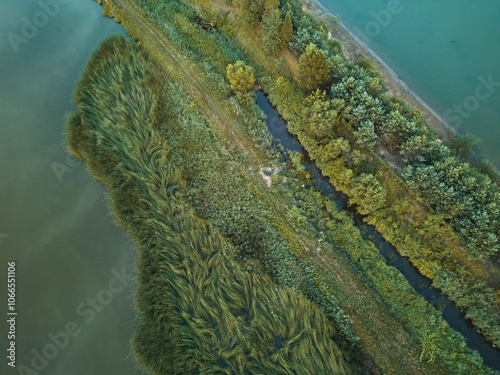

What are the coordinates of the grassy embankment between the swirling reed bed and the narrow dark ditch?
(69, 3, 496, 373)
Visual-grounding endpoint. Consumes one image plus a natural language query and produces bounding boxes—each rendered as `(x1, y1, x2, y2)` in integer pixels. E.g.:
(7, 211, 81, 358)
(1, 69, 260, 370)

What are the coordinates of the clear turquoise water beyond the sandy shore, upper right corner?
(320, 0, 500, 167)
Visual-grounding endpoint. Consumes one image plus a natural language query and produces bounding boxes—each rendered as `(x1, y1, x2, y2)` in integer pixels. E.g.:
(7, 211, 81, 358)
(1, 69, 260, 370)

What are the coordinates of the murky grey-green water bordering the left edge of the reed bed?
(0, 0, 141, 375)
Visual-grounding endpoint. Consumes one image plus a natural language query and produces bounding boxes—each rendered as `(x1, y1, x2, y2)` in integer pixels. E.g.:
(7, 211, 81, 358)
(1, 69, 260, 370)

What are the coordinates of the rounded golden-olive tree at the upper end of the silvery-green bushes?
(297, 43, 329, 91)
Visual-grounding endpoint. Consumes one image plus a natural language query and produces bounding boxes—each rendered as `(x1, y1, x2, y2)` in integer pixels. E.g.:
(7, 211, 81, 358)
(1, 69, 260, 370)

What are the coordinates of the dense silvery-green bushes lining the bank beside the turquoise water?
(258, 2, 500, 258)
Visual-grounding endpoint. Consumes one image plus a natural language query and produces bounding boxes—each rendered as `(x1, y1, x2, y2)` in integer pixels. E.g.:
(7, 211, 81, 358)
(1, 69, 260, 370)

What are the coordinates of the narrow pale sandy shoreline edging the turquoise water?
(302, 0, 498, 173)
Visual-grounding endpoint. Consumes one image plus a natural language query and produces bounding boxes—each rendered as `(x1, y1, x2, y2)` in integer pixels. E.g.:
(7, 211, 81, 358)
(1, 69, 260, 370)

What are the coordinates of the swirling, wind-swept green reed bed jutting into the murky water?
(68, 38, 348, 375)
